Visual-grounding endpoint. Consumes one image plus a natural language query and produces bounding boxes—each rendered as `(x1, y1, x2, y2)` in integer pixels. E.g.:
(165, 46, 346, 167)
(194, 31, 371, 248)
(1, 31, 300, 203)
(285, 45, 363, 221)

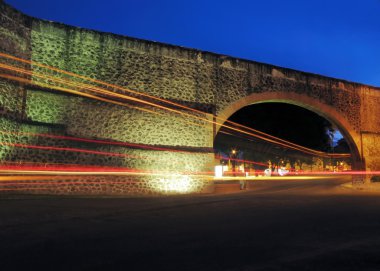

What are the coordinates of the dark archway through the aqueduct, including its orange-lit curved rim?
(214, 93, 364, 175)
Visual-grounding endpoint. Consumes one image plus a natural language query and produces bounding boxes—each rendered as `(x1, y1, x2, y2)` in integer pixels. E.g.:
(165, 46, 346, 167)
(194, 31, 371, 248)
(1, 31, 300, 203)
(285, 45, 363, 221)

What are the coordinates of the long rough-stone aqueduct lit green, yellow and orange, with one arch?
(0, 1, 380, 194)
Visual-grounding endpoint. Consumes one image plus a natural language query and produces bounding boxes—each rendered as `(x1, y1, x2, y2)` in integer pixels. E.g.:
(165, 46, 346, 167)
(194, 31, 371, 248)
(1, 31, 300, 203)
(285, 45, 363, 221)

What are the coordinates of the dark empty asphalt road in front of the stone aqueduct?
(0, 179, 380, 271)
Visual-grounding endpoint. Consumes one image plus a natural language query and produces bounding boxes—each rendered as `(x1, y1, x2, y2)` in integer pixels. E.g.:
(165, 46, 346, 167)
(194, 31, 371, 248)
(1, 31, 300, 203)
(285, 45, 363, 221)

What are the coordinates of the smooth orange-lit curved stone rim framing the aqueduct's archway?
(214, 92, 365, 170)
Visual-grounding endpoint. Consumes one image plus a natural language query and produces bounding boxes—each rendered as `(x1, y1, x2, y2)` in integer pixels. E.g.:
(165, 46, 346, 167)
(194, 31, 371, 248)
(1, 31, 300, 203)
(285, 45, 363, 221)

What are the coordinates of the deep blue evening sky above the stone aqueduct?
(5, 0, 380, 86)
